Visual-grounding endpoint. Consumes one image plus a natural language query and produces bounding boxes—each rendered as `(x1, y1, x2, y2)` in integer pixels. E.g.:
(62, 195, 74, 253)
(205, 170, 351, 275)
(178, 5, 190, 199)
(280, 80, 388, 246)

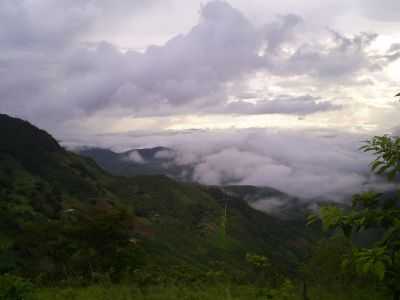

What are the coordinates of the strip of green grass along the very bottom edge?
(38, 285, 386, 300)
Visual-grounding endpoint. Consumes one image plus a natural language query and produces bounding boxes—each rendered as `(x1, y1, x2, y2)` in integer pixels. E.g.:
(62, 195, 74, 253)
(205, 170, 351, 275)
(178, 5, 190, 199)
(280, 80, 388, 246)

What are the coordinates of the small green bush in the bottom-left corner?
(0, 275, 36, 300)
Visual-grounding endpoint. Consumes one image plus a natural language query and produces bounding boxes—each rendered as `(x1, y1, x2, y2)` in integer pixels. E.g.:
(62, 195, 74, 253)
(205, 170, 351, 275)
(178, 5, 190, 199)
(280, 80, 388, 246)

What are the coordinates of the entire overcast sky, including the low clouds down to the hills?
(0, 0, 400, 197)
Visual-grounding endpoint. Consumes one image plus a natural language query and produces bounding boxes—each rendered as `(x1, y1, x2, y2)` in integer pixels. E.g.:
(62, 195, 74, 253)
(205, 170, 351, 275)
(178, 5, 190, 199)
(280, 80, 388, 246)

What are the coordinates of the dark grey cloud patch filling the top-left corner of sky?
(0, 0, 90, 51)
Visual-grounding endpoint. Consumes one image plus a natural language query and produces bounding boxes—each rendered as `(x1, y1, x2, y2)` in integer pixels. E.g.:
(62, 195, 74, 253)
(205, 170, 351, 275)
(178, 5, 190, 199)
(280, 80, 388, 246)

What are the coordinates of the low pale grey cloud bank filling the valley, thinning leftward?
(64, 129, 391, 200)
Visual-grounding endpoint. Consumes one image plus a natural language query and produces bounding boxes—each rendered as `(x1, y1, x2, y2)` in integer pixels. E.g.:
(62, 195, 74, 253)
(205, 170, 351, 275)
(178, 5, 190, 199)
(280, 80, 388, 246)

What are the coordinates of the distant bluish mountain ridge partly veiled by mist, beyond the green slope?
(78, 147, 310, 218)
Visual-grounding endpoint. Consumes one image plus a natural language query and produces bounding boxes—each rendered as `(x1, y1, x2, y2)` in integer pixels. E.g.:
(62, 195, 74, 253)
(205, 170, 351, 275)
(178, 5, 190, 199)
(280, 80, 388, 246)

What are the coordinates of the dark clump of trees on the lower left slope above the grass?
(10, 204, 143, 282)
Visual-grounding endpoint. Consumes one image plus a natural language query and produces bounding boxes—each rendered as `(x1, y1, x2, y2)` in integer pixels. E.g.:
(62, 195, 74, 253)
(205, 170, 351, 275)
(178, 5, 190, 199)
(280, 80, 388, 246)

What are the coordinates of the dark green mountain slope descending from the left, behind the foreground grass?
(0, 115, 316, 282)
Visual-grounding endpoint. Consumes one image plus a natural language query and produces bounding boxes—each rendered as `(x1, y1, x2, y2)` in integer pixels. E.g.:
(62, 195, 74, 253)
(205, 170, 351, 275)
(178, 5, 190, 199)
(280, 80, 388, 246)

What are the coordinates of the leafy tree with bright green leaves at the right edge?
(310, 136, 400, 300)
